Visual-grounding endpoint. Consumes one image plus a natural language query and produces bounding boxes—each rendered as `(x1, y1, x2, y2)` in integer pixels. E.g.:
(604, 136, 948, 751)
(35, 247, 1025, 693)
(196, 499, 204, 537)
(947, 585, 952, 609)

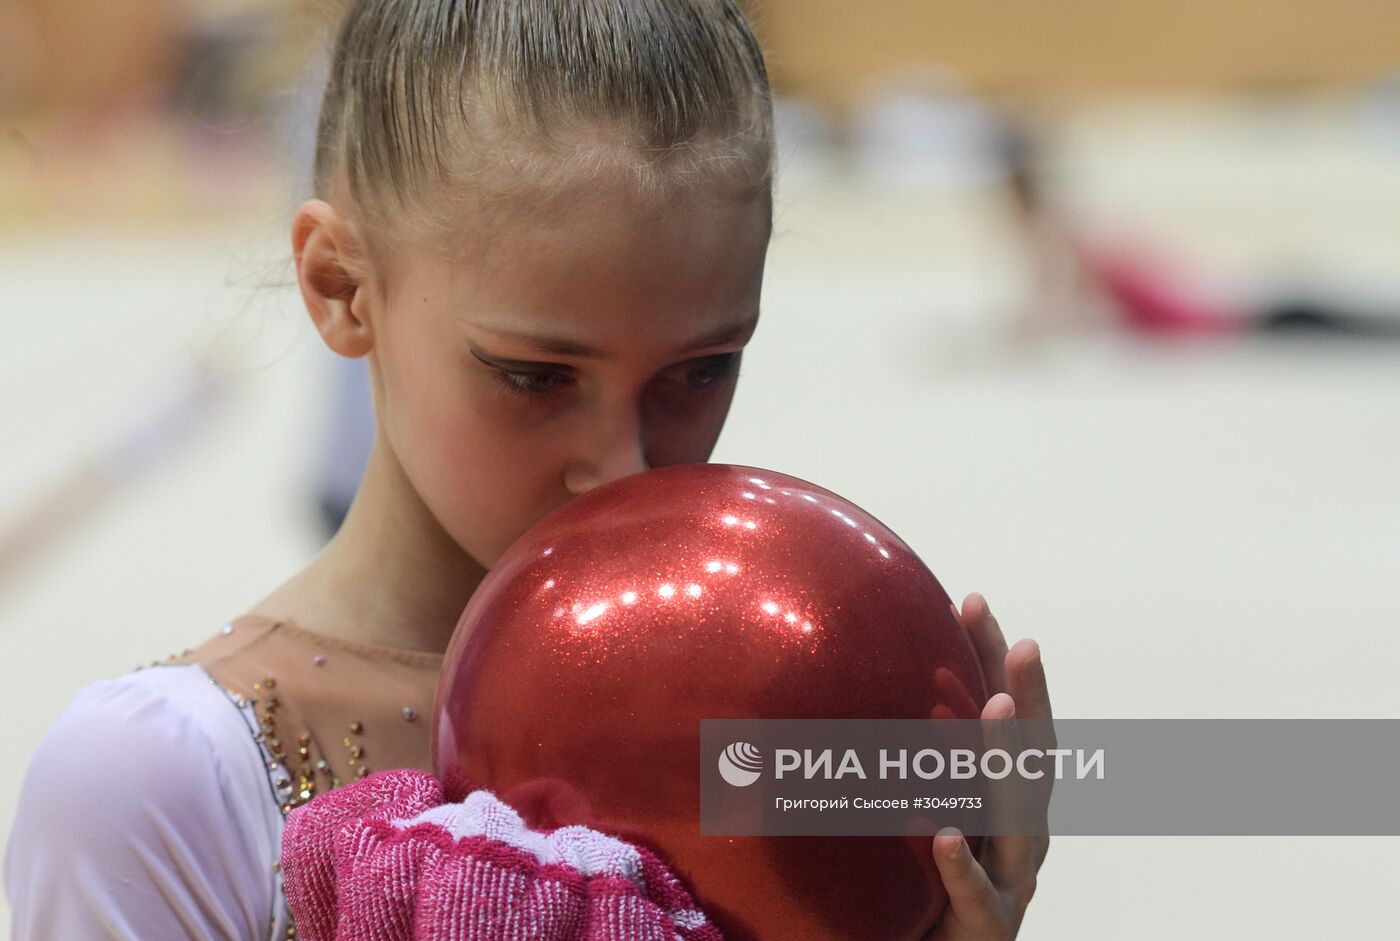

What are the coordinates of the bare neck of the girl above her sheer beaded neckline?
(253, 435, 486, 653)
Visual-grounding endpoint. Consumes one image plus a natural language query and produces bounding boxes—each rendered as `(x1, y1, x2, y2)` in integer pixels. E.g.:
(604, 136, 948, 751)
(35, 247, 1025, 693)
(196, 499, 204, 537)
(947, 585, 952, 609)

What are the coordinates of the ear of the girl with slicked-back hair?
(291, 199, 374, 358)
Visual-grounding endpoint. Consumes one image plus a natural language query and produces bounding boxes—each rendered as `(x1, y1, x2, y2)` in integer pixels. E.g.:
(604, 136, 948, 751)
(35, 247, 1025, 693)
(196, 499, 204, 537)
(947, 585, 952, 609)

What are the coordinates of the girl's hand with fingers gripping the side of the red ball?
(927, 594, 1056, 941)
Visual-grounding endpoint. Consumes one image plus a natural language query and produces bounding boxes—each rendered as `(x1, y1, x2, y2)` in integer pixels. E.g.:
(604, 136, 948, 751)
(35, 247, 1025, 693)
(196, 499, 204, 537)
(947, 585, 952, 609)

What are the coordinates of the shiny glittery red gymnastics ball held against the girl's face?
(433, 463, 987, 941)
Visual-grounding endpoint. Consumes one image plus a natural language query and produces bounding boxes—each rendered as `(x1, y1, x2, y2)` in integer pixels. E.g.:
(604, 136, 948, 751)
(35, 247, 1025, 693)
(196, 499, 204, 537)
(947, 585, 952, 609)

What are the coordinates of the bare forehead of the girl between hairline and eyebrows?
(410, 174, 771, 349)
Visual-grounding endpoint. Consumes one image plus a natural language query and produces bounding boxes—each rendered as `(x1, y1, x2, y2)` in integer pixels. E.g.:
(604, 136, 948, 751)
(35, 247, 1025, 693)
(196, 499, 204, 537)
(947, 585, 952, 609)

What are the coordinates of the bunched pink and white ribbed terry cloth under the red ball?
(281, 770, 722, 941)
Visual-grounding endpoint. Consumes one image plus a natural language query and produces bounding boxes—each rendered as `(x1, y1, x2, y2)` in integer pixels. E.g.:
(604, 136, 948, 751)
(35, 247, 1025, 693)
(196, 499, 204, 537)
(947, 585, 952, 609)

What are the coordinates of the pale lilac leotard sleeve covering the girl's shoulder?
(6, 665, 281, 938)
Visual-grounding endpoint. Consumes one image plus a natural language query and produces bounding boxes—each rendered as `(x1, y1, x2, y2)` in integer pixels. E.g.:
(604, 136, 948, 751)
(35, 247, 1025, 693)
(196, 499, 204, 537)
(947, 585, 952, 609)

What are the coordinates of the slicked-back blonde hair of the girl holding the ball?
(314, 0, 773, 242)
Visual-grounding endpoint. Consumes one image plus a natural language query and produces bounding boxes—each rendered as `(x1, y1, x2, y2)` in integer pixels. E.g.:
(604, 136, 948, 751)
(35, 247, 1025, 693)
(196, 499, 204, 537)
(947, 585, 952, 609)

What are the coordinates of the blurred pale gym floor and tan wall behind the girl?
(0, 0, 1400, 940)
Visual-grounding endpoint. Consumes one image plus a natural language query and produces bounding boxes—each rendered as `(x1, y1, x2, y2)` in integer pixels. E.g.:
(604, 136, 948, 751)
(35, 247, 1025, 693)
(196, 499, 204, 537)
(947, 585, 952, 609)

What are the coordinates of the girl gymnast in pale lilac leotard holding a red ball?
(6, 0, 1050, 941)
